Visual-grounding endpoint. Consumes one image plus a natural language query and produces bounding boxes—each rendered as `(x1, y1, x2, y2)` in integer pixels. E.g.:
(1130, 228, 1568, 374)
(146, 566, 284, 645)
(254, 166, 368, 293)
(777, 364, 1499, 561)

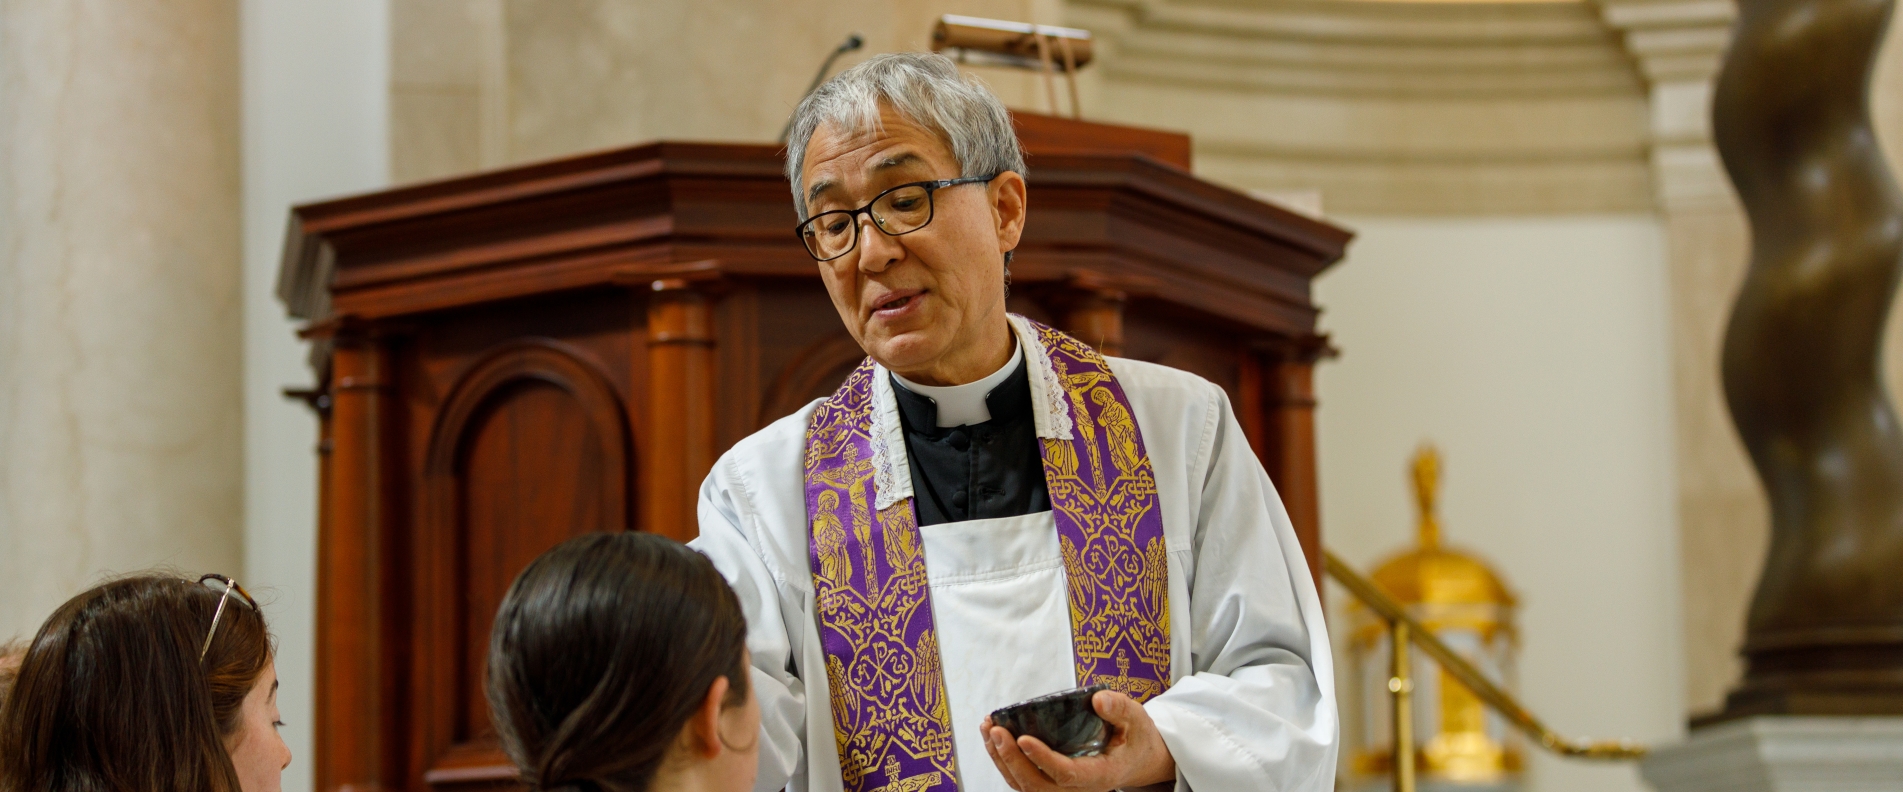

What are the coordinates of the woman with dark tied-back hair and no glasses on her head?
(487, 533, 759, 792)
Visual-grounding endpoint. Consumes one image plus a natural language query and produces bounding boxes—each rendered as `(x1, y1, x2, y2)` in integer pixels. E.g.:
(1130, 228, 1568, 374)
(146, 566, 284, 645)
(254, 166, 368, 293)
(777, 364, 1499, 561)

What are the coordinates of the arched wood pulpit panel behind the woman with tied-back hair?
(413, 339, 634, 786)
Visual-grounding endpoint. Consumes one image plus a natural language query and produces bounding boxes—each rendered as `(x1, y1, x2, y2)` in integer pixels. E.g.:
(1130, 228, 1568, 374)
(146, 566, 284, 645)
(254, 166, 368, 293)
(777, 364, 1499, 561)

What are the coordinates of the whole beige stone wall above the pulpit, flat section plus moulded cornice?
(390, 0, 1652, 215)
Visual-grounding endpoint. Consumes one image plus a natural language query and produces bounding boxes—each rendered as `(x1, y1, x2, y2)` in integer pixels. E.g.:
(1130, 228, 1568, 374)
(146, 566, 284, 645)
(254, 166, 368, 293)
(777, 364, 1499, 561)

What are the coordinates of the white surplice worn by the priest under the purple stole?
(693, 316, 1340, 792)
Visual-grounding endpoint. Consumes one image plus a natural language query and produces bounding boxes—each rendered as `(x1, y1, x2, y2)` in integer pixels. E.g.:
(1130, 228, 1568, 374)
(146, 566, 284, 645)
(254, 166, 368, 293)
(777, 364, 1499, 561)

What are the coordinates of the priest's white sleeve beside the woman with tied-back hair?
(689, 457, 807, 792)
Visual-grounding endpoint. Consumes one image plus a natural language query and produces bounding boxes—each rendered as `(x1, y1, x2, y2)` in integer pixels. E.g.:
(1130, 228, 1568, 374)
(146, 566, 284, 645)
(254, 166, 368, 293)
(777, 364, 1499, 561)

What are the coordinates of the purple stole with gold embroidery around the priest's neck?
(805, 322, 1170, 792)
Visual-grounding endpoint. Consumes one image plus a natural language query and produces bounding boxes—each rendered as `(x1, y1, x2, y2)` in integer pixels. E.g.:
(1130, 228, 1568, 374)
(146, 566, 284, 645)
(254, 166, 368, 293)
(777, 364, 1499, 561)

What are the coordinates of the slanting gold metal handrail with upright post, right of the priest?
(1323, 550, 1646, 792)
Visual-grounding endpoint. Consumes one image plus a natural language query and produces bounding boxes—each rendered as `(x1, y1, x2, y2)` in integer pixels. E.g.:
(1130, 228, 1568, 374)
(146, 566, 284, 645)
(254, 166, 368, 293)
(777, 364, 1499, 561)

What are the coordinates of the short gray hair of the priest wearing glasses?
(786, 51, 1026, 221)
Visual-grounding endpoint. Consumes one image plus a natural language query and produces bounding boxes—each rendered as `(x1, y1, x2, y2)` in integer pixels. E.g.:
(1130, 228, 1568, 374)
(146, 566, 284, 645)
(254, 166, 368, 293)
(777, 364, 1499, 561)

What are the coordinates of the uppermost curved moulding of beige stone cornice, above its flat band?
(1069, 0, 1640, 99)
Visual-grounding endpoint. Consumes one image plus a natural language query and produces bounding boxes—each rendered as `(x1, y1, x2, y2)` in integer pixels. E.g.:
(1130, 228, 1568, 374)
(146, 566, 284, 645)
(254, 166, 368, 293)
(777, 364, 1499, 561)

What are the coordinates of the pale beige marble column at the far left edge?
(0, 0, 244, 640)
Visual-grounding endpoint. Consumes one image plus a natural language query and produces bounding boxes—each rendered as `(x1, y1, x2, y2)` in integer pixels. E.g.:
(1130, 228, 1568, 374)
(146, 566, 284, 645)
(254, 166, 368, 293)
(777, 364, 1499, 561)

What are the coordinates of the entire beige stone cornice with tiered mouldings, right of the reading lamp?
(1064, 0, 1654, 215)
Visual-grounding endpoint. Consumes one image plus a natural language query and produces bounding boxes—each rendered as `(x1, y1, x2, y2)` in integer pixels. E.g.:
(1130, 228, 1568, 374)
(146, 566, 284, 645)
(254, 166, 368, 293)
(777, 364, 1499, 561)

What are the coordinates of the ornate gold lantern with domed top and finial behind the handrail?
(1349, 446, 1522, 790)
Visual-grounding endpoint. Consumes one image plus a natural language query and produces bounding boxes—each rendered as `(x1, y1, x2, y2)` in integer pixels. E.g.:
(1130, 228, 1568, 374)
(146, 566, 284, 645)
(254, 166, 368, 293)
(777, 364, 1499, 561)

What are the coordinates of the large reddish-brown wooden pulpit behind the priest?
(280, 116, 1349, 792)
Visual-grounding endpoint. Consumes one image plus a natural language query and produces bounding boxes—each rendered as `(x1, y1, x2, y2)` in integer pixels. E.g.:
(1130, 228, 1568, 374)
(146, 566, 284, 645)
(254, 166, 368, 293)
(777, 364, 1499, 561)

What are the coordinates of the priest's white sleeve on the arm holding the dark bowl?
(1144, 386, 1340, 792)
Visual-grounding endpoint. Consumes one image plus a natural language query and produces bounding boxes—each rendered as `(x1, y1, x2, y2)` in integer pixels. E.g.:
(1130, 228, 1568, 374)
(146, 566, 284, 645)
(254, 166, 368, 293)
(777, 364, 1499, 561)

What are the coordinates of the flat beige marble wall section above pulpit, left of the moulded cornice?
(390, 0, 1062, 181)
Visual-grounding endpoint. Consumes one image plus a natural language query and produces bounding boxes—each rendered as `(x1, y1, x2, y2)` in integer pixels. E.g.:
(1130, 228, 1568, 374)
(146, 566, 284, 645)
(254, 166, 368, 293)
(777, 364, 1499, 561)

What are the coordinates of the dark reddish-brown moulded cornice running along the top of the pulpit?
(280, 143, 1353, 335)
